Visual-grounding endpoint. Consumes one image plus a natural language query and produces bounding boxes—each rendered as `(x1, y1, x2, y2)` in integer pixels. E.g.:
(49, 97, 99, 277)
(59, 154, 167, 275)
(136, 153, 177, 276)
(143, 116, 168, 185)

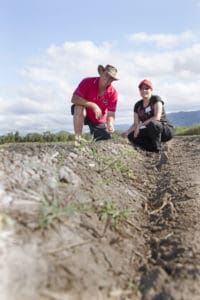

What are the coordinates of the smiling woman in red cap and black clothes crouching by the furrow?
(125, 79, 174, 152)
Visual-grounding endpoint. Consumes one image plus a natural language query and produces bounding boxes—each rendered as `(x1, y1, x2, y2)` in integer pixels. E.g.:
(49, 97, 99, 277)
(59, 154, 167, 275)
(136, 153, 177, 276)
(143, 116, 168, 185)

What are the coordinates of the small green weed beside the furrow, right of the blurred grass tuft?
(97, 201, 129, 228)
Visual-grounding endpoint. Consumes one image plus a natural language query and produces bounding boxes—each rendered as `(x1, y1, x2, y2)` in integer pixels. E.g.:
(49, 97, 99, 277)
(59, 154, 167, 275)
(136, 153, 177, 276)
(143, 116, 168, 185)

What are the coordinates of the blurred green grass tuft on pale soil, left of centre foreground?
(38, 195, 84, 228)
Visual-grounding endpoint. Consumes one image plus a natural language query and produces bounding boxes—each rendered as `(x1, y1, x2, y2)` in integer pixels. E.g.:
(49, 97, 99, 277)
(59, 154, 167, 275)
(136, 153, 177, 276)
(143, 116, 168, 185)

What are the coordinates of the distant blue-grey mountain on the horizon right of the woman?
(167, 110, 200, 126)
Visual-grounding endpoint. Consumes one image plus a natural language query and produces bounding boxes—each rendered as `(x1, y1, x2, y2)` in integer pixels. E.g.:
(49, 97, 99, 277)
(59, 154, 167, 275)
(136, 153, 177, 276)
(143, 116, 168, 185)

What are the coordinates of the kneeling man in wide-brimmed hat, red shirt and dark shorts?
(71, 65, 118, 142)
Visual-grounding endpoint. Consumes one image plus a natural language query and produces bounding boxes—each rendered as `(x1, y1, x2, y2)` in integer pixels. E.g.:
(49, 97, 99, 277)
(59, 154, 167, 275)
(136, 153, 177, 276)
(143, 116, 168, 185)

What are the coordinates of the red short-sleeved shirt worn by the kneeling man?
(74, 77, 118, 123)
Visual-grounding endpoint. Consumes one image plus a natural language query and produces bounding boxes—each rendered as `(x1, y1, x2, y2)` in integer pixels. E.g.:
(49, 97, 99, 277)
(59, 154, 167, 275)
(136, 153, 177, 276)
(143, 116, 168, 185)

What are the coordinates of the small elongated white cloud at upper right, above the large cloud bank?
(128, 31, 197, 49)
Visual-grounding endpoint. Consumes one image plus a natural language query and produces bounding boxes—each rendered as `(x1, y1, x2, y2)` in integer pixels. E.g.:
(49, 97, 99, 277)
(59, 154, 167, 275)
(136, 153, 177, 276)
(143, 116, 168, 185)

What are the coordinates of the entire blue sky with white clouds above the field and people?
(0, 0, 200, 134)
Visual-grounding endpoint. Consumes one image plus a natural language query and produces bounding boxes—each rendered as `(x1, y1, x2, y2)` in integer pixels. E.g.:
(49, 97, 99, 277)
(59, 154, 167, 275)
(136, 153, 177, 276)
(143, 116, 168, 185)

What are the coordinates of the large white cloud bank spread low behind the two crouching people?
(0, 33, 200, 132)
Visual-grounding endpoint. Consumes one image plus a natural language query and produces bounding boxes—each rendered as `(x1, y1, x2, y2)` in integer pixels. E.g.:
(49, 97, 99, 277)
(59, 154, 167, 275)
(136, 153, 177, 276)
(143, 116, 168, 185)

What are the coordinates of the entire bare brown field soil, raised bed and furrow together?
(0, 137, 200, 300)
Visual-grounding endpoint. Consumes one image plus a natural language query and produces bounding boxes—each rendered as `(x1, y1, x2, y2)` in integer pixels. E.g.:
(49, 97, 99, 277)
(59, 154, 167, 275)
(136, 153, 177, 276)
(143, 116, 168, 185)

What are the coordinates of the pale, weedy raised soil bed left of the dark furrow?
(0, 142, 146, 300)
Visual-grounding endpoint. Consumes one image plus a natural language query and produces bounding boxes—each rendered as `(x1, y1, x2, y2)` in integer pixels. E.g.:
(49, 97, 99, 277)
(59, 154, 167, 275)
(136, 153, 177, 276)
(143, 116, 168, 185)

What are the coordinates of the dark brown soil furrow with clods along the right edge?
(141, 138, 200, 300)
